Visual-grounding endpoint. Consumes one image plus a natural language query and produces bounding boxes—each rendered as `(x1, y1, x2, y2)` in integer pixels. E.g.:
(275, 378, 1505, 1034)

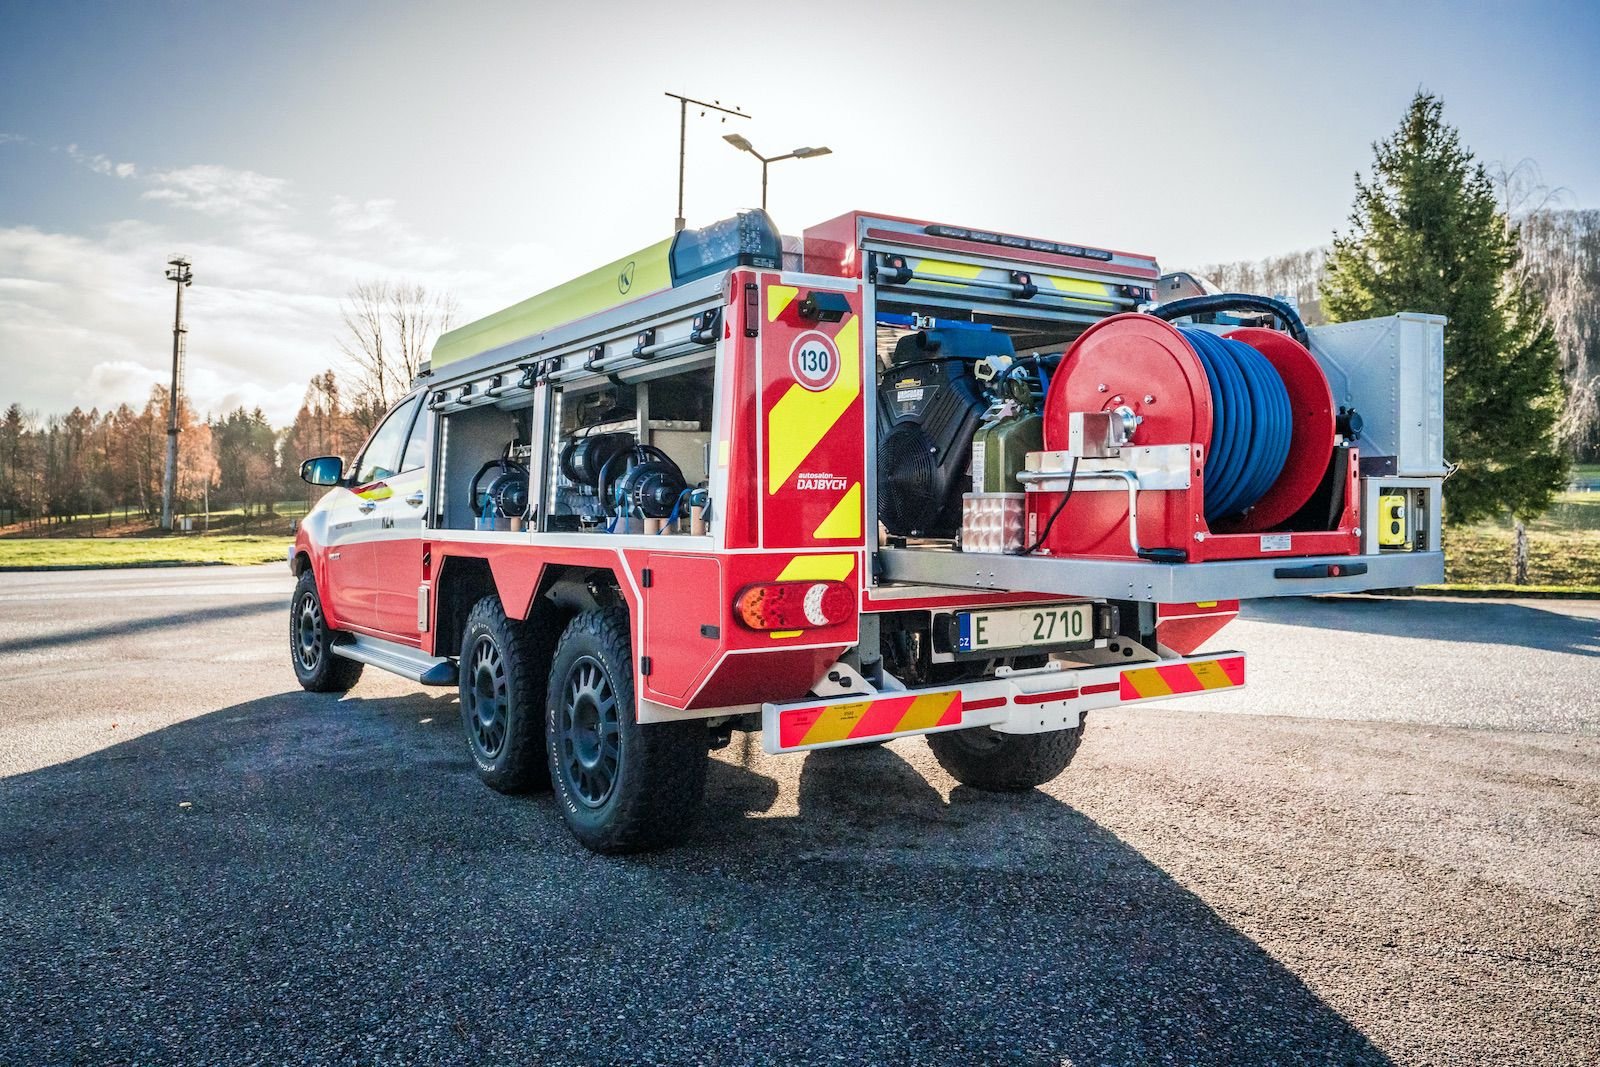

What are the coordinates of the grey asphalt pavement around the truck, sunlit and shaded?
(0, 565, 1600, 1067)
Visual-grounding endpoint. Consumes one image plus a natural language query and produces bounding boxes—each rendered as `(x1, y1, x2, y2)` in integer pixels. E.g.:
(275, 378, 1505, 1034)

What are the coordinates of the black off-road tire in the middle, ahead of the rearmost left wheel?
(458, 593, 550, 793)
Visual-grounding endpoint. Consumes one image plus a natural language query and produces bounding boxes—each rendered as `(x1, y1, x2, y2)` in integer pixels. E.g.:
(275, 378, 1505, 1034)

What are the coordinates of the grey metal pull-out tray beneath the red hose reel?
(878, 547, 1445, 603)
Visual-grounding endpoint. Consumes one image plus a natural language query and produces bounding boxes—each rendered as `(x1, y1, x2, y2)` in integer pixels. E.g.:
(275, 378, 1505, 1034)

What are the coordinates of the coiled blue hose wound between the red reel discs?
(1178, 326, 1294, 523)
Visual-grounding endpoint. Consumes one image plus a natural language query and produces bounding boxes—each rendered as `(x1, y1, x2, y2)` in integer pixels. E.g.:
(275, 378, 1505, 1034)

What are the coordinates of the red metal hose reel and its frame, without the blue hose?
(1029, 314, 1358, 560)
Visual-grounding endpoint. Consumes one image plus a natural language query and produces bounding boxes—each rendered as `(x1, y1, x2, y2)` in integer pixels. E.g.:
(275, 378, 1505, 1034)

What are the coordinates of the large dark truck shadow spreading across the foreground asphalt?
(0, 689, 1389, 1064)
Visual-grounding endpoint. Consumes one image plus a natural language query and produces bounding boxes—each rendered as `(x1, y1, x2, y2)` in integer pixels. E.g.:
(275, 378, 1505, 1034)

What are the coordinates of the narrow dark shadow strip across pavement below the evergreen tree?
(1248, 597, 1600, 656)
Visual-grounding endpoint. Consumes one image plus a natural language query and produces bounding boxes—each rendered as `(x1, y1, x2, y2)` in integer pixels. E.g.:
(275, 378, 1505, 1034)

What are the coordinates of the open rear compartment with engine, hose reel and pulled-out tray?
(803, 213, 1445, 603)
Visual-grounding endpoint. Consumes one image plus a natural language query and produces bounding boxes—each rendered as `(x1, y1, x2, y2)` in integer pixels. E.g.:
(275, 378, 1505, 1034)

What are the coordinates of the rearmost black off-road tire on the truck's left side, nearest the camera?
(544, 606, 710, 854)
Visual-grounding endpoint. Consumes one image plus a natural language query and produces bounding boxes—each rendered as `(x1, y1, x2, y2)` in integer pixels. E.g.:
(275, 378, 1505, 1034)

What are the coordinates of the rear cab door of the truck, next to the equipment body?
(368, 408, 432, 645)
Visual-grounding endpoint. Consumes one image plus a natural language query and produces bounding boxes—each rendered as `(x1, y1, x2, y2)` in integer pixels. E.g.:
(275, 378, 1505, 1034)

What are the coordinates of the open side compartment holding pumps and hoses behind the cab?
(422, 255, 722, 536)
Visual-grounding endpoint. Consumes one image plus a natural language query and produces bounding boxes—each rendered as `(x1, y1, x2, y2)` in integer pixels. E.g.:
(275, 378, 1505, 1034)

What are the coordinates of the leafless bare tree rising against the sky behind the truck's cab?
(339, 282, 456, 416)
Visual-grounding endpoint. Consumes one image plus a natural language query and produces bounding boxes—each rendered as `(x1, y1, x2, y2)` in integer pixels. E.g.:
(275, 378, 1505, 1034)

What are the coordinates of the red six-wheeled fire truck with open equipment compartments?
(290, 211, 1446, 851)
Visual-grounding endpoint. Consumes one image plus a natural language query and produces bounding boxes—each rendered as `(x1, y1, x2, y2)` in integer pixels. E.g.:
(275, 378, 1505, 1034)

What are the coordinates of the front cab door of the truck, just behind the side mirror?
(328, 397, 419, 630)
